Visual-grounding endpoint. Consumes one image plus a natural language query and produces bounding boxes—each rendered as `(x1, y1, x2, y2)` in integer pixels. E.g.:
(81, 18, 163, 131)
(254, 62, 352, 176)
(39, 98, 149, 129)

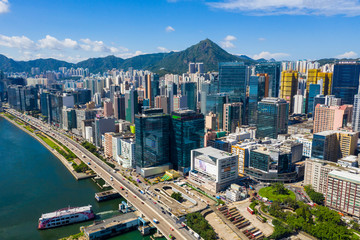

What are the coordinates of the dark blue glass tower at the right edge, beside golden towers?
(331, 62, 360, 104)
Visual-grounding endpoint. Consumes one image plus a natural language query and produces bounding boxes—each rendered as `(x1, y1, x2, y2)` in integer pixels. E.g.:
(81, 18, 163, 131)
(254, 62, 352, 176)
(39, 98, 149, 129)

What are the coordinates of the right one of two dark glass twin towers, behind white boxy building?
(170, 110, 204, 173)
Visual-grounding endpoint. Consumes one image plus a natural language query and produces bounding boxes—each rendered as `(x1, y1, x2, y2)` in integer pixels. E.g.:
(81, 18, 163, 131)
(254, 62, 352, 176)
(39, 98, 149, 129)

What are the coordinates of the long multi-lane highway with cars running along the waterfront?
(6, 109, 196, 239)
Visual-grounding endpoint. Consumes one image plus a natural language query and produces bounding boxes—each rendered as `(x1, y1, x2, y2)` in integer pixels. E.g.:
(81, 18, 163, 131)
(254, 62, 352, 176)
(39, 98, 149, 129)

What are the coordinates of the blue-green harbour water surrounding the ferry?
(0, 117, 160, 240)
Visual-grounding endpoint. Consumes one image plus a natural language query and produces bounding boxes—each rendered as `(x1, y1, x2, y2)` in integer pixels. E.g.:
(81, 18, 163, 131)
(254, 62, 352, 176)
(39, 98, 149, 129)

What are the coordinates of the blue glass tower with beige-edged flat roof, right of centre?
(256, 98, 289, 139)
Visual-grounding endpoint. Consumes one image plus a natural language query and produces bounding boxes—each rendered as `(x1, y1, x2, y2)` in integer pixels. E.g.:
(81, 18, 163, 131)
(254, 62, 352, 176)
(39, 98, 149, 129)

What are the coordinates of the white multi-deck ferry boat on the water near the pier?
(38, 205, 95, 229)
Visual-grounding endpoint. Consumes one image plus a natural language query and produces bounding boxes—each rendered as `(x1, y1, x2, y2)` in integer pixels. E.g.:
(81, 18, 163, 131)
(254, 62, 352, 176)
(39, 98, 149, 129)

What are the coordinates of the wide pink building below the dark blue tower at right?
(314, 104, 353, 133)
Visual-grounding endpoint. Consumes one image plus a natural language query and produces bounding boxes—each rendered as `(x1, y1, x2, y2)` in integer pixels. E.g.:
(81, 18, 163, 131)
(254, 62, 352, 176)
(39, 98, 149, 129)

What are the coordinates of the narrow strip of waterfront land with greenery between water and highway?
(0, 113, 95, 180)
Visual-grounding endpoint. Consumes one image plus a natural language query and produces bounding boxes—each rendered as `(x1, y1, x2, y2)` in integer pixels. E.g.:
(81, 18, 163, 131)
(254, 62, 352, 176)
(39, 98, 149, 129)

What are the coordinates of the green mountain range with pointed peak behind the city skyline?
(0, 39, 257, 74)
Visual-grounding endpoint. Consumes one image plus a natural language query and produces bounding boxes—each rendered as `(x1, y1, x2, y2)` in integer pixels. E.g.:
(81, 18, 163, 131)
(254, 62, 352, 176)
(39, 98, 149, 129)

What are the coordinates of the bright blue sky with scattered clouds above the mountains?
(0, 0, 360, 63)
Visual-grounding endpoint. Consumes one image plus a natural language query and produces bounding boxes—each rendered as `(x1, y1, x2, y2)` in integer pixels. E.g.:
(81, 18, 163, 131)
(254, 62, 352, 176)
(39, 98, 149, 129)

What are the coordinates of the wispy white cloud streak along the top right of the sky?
(208, 0, 360, 16)
